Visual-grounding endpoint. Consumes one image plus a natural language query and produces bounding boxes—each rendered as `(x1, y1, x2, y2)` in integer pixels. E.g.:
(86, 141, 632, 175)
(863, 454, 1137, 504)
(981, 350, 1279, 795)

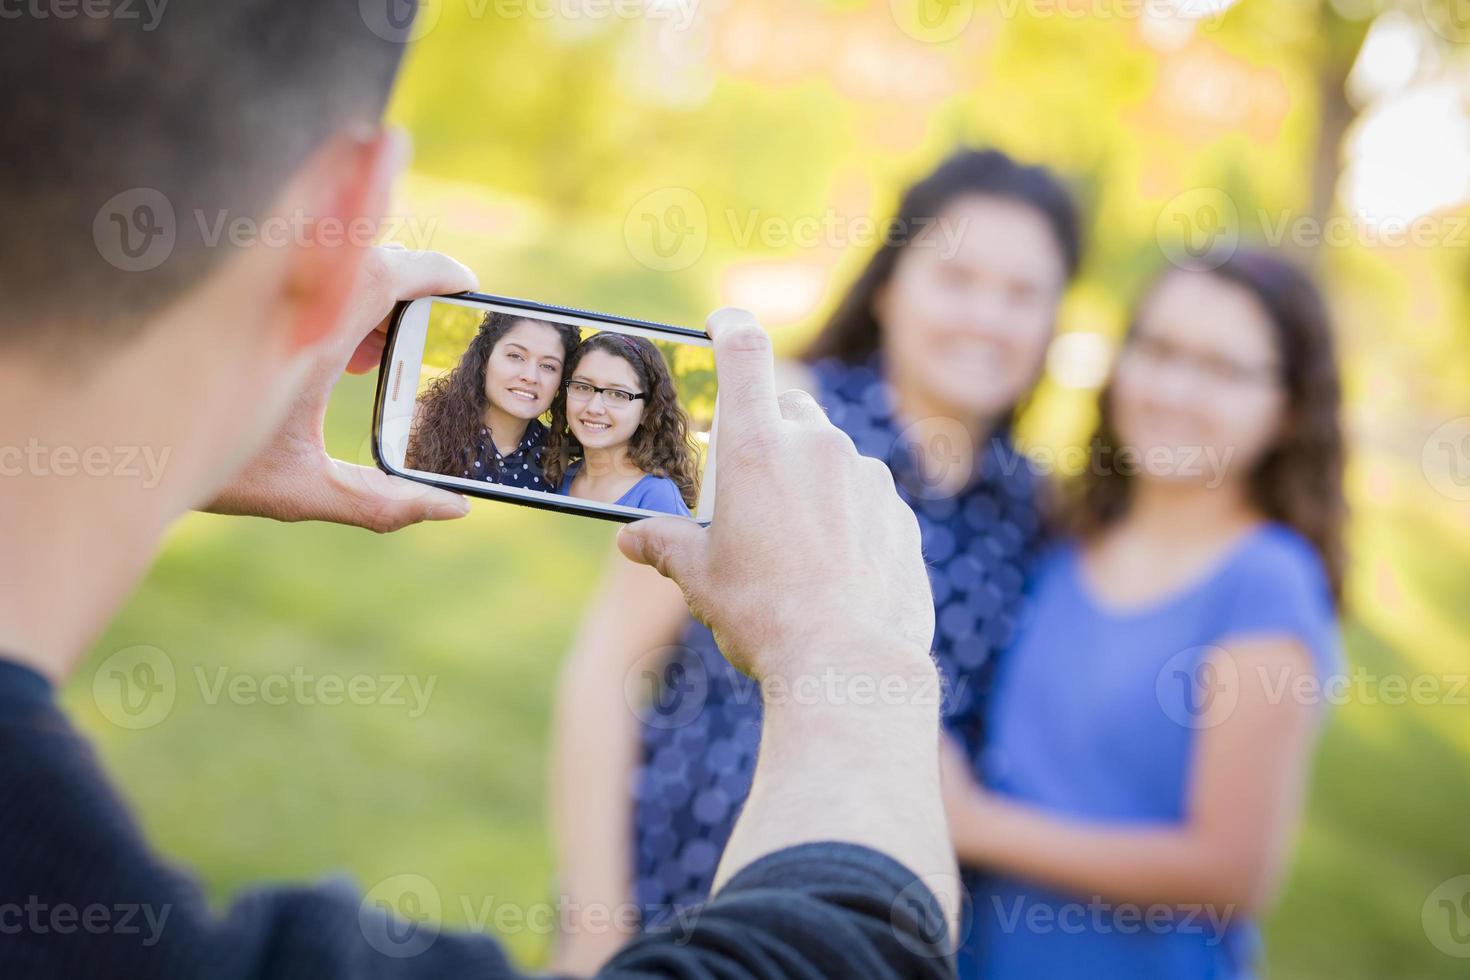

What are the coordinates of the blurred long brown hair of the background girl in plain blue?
(1063, 251, 1348, 607)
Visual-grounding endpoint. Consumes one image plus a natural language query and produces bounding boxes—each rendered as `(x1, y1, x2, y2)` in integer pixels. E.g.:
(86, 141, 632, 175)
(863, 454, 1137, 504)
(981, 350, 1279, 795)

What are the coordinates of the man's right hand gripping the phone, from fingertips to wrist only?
(617, 309, 933, 680)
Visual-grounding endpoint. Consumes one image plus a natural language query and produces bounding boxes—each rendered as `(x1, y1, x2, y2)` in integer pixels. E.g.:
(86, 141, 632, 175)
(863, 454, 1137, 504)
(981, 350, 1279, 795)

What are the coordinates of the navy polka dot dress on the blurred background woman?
(632, 361, 1042, 927)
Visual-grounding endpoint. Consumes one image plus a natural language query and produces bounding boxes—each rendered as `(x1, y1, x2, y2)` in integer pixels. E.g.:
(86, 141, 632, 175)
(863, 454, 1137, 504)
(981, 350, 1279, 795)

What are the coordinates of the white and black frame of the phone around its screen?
(372, 292, 719, 526)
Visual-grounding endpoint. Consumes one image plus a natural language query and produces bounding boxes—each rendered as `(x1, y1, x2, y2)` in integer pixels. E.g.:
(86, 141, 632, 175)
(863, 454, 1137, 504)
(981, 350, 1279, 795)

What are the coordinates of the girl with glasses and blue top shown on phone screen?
(545, 332, 700, 516)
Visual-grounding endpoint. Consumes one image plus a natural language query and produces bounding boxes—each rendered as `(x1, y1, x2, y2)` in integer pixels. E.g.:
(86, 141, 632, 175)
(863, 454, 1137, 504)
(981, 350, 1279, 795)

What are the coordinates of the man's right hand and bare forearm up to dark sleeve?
(617, 310, 960, 955)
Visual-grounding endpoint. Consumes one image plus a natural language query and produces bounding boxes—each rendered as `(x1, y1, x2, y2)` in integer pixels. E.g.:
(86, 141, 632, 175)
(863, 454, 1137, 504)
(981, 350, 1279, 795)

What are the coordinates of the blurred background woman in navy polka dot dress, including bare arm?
(553, 150, 1080, 973)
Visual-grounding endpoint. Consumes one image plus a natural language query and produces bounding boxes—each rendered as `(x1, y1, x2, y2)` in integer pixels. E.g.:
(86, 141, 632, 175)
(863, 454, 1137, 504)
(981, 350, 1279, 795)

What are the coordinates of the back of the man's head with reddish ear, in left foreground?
(0, 0, 413, 511)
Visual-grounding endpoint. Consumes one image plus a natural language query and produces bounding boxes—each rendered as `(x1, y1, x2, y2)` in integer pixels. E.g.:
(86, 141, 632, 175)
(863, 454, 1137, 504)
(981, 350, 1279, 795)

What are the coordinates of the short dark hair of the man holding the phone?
(0, 0, 413, 350)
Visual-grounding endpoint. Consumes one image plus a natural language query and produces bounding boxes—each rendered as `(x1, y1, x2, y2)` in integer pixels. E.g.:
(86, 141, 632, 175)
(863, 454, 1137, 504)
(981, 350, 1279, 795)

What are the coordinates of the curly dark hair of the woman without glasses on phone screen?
(404, 310, 582, 478)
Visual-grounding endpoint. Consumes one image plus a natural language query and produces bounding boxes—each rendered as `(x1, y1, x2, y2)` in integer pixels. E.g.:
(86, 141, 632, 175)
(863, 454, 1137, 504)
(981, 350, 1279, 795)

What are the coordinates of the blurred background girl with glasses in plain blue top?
(945, 254, 1345, 979)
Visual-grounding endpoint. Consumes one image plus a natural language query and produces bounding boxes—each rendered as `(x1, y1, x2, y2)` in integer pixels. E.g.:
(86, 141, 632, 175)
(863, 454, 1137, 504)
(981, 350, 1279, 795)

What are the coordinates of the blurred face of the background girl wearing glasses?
(1111, 272, 1286, 482)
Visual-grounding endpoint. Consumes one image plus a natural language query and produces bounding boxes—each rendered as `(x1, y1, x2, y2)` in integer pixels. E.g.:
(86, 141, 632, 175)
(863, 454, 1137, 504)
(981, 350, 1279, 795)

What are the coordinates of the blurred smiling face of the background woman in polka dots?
(873, 195, 1067, 419)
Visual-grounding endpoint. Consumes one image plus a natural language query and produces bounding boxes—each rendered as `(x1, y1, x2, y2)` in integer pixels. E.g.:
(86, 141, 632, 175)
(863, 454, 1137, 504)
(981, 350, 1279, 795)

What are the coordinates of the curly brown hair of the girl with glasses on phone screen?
(544, 331, 700, 510)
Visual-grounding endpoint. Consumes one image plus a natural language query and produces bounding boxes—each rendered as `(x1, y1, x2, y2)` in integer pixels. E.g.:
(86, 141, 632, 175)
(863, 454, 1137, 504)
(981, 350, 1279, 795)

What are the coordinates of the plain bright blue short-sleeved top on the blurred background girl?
(960, 525, 1341, 980)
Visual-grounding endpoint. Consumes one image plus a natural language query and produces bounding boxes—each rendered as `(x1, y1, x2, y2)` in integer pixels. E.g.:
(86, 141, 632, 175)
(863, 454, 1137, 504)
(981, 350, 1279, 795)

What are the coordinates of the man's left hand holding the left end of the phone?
(204, 245, 478, 532)
